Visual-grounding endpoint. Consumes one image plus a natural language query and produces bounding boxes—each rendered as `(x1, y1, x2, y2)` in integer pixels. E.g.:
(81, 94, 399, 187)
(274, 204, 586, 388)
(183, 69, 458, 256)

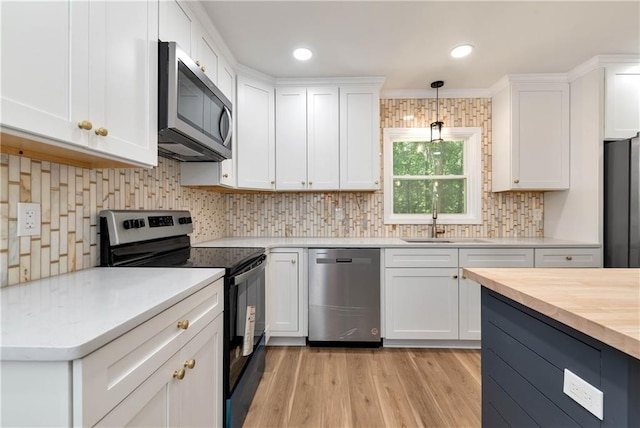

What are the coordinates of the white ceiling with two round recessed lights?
(202, 0, 640, 90)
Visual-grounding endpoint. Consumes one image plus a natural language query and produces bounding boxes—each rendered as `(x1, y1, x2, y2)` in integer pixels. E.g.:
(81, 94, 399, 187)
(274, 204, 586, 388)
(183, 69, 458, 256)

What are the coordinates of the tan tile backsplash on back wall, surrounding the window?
(228, 98, 544, 237)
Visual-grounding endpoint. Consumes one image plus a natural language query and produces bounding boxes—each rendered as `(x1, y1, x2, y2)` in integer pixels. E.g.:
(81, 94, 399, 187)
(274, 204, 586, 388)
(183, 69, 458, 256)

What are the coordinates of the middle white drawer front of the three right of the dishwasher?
(460, 248, 533, 268)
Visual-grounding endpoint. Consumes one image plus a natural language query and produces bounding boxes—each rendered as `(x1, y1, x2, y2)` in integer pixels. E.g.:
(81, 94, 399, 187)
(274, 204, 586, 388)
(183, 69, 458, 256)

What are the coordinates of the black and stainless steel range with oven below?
(100, 210, 266, 427)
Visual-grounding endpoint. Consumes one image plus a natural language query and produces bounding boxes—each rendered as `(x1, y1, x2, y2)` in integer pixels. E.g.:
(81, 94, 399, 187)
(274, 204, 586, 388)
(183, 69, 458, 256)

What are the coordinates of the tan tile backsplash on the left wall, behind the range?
(0, 154, 227, 286)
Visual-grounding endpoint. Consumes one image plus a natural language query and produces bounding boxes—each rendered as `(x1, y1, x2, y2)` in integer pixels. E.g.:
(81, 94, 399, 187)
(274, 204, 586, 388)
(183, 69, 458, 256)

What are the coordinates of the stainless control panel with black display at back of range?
(100, 210, 193, 246)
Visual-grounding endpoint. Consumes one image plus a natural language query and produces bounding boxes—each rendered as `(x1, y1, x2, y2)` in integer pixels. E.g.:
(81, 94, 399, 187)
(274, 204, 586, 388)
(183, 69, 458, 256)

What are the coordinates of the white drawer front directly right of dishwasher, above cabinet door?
(384, 248, 458, 268)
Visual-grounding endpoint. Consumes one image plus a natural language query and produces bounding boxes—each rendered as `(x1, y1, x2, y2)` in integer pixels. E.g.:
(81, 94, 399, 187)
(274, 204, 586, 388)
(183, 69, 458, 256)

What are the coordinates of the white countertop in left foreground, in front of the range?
(0, 267, 224, 361)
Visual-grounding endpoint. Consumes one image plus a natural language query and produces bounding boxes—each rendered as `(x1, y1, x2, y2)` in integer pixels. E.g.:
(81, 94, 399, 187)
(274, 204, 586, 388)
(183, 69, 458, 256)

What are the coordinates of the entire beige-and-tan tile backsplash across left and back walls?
(0, 98, 543, 286)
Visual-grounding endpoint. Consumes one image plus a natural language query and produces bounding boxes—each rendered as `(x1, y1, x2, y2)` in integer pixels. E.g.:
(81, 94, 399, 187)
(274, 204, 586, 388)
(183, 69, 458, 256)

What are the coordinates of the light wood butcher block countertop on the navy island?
(464, 268, 640, 359)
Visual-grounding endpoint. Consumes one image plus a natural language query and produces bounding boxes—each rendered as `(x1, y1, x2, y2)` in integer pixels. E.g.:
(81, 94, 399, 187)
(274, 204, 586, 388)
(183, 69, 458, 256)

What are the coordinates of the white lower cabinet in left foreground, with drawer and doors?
(0, 279, 224, 427)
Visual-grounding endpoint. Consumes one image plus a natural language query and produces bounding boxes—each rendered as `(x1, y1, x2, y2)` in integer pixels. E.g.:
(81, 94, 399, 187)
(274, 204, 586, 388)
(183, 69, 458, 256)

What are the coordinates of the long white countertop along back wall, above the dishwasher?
(192, 237, 600, 249)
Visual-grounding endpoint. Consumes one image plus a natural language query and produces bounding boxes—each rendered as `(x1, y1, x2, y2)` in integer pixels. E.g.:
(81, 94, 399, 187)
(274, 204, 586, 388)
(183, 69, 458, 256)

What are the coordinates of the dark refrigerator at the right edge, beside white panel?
(604, 132, 640, 268)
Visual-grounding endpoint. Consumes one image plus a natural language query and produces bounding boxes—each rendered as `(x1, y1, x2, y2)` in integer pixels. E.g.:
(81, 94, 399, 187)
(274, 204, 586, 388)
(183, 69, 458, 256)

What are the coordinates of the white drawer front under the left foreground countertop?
(73, 278, 224, 426)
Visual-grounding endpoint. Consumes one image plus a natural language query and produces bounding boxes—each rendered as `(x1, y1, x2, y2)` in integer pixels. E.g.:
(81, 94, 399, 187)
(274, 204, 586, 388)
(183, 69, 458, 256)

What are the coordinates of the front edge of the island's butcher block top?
(463, 268, 640, 360)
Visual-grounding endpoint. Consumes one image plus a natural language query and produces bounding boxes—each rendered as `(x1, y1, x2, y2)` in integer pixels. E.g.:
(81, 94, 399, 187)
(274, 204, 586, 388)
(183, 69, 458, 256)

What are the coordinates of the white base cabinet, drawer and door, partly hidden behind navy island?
(459, 248, 533, 340)
